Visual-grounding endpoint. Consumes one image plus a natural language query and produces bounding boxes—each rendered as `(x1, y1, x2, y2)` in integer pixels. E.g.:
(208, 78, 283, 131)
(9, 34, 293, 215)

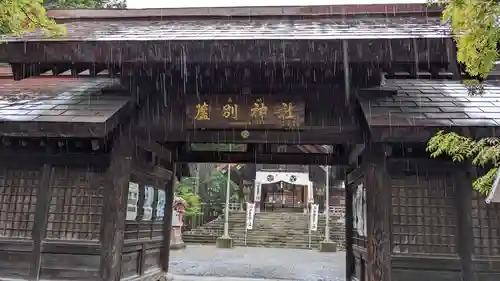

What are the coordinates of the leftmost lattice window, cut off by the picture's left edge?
(0, 169, 38, 239)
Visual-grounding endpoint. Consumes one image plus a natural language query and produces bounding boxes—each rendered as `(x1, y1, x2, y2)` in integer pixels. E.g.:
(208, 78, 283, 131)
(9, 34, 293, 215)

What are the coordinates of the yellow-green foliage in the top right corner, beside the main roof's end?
(431, 0, 500, 78)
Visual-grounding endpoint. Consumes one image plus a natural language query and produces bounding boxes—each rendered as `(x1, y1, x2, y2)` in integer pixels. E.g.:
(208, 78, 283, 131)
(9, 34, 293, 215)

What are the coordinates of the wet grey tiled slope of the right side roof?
(360, 80, 500, 127)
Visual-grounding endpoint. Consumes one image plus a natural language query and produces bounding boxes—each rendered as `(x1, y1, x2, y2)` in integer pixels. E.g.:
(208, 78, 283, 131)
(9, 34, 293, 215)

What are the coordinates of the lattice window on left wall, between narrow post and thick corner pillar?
(46, 168, 103, 240)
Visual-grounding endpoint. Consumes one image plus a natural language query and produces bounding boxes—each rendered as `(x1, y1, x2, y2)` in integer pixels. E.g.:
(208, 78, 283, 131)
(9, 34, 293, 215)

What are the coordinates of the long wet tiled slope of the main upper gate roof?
(1, 17, 450, 42)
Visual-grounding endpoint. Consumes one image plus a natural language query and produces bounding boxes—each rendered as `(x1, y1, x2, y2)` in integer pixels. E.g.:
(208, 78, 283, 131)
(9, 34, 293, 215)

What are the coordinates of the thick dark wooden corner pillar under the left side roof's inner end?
(101, 135, 134, 281)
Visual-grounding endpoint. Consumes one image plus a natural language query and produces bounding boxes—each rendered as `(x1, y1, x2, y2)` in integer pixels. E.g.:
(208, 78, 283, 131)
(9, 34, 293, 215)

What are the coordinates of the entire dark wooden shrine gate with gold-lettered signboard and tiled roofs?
(0, 4, 500, 281)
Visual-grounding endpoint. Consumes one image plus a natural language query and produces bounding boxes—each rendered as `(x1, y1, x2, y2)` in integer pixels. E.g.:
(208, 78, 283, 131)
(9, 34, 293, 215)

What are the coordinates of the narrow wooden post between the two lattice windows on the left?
(29, 164, 52, 281)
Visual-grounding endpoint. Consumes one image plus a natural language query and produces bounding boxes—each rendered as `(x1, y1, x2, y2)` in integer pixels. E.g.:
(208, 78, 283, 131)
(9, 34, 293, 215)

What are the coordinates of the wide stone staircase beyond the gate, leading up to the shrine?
(183, 212, 345, 250)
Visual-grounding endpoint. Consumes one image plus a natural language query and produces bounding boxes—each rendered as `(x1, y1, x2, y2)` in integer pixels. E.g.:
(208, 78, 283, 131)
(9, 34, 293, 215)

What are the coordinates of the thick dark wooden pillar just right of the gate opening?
(362, 143, 392, 281)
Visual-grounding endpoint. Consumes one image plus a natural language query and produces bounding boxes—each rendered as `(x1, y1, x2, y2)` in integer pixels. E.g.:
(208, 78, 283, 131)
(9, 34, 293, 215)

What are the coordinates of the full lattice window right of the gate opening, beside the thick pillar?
(392, 176, 456, 254)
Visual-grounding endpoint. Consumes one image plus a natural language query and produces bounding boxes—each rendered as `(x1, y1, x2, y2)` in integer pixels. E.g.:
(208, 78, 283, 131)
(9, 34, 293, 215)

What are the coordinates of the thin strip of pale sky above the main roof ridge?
(127, 0, 427, 9)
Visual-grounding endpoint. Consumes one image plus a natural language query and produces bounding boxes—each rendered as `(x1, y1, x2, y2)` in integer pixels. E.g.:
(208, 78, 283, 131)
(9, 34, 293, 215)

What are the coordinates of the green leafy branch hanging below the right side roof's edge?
(427, 131, 500, 195)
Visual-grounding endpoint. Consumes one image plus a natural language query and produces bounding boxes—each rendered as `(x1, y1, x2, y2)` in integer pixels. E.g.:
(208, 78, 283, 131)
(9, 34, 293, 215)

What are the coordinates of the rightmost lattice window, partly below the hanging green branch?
(472, 194, 500, 256)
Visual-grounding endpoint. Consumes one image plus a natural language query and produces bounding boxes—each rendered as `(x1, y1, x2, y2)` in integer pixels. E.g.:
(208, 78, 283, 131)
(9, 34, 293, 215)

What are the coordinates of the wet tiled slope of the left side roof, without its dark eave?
(0, 77, 128, 123)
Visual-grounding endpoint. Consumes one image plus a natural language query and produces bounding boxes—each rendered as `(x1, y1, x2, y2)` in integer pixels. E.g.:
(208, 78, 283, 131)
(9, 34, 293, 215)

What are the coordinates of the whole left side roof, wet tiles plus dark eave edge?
(0, 76, 129, 137)
